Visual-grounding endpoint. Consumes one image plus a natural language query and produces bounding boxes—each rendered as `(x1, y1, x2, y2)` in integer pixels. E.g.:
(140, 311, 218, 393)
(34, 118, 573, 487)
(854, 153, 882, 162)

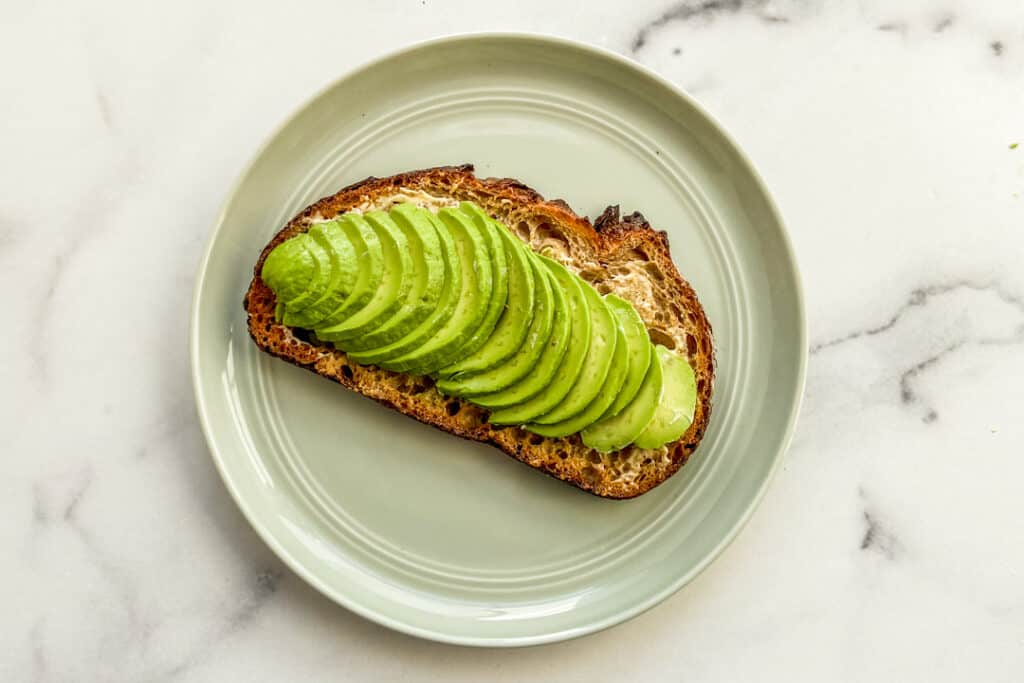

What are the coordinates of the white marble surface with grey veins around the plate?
(0, 0, 1024, 682)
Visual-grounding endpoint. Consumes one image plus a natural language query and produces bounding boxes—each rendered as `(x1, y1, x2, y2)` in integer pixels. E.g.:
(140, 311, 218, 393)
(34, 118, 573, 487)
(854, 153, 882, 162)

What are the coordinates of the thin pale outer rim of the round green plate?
(188, 31, 810, 647)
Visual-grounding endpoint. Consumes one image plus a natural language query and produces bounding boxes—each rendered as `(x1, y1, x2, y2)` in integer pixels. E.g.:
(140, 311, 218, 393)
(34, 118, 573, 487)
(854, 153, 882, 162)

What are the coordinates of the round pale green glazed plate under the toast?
(191, 35, 807, 646)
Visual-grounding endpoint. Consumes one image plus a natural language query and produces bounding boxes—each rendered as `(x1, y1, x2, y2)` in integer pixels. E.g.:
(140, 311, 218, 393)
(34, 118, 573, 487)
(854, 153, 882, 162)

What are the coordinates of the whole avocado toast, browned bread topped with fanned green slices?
(245, 166, 714, 498)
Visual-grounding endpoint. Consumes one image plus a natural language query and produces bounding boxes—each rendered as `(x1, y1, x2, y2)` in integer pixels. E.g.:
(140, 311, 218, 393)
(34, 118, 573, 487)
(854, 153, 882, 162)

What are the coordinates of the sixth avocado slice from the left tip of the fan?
(337, 203, 446, 351)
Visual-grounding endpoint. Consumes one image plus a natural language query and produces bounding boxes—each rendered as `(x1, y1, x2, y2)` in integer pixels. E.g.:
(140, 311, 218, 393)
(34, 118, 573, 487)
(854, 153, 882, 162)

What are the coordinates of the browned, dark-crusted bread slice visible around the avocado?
(245, 165, 715, 499)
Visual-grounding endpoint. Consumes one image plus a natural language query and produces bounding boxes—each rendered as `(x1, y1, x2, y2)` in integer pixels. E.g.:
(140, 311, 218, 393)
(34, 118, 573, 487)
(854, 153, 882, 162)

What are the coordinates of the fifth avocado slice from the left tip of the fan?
(315, 211, 414, 350)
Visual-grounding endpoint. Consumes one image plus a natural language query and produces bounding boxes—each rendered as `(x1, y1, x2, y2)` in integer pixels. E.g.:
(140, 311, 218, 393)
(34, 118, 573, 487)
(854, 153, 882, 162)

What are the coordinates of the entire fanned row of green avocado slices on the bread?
(261, 202, 696, 452)
